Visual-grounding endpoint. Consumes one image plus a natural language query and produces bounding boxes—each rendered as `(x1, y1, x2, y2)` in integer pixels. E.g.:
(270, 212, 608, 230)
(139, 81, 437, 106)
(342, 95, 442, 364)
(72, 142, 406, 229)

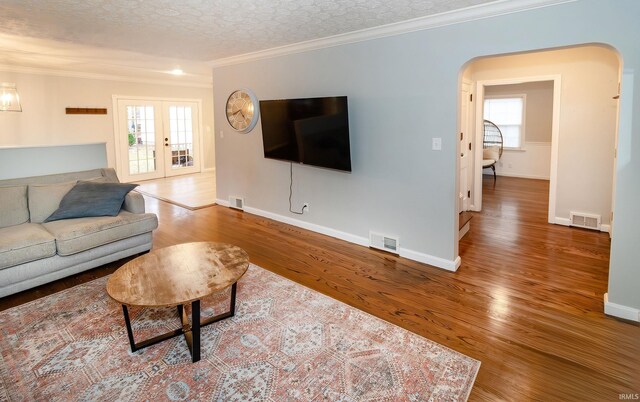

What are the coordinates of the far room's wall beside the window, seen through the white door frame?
(488, 80, 553, 180)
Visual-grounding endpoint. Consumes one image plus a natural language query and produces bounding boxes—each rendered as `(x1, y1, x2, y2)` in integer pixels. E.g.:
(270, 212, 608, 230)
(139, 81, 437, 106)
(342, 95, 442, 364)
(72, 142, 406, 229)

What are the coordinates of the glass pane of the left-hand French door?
(127, 106, 157, 175)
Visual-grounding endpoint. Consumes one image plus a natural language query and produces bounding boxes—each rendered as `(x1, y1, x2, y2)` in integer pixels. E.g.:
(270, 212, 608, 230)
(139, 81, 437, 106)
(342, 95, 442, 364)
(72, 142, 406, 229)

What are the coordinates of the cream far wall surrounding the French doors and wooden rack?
(0, 71, 215, 173)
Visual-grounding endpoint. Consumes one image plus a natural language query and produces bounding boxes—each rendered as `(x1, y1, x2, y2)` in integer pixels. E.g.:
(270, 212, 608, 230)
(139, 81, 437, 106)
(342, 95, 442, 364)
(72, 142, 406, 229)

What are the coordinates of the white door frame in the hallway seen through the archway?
(471, 74, 562, 223)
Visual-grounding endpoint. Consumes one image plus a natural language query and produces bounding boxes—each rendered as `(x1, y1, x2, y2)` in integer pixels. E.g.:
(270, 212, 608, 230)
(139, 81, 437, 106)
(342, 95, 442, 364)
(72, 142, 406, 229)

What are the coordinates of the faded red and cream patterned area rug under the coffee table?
(0, 265, 480, 401)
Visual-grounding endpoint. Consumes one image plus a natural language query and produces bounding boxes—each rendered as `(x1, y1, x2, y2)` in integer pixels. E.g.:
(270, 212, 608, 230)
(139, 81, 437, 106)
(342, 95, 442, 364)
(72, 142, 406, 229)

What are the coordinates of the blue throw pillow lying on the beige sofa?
(45, 181, 138, 222)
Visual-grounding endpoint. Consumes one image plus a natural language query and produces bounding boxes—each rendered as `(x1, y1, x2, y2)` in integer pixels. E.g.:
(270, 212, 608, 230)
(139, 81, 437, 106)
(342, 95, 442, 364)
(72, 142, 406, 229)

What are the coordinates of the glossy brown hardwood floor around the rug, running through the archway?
(0, 177, 640, 401)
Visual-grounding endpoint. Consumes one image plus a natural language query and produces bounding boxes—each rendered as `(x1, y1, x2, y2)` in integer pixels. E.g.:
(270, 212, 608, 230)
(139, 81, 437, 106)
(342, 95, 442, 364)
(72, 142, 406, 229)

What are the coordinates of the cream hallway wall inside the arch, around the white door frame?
(470, 46, 620, 225)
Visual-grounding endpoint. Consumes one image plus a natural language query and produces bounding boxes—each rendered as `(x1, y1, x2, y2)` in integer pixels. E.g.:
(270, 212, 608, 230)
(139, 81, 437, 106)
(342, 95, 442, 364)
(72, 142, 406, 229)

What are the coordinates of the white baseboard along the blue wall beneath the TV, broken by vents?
(216, 199, 461, 272)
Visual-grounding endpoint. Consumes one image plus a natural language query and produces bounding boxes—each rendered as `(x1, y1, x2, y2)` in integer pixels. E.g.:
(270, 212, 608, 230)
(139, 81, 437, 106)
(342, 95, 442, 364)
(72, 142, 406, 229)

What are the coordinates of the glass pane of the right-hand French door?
(169, 106, 193, 169)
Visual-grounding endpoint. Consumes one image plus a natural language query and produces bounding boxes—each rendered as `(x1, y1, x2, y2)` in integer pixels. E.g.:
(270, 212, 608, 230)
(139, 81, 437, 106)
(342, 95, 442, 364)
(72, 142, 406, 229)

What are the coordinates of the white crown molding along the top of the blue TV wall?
(209, 0, 578, 68)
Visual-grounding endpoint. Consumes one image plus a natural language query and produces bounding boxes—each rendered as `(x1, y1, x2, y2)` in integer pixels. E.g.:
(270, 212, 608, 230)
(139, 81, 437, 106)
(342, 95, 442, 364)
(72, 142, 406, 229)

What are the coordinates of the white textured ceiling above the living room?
(0, 0, 494, 61)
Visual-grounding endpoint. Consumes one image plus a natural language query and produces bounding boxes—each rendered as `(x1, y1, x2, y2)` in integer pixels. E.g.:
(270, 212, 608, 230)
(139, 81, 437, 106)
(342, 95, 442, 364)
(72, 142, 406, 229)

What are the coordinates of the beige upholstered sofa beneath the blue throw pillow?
(0, 169, 158, 297)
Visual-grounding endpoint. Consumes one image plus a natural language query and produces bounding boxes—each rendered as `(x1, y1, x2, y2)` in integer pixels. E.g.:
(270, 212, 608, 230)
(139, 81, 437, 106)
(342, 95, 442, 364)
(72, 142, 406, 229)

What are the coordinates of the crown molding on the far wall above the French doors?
(0, 64, 213, 89)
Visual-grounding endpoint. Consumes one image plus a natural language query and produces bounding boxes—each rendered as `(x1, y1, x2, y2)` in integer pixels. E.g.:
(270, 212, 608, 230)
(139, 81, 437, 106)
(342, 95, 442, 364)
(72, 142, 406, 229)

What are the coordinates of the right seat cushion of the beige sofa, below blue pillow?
(42, 211, 158, 256)
